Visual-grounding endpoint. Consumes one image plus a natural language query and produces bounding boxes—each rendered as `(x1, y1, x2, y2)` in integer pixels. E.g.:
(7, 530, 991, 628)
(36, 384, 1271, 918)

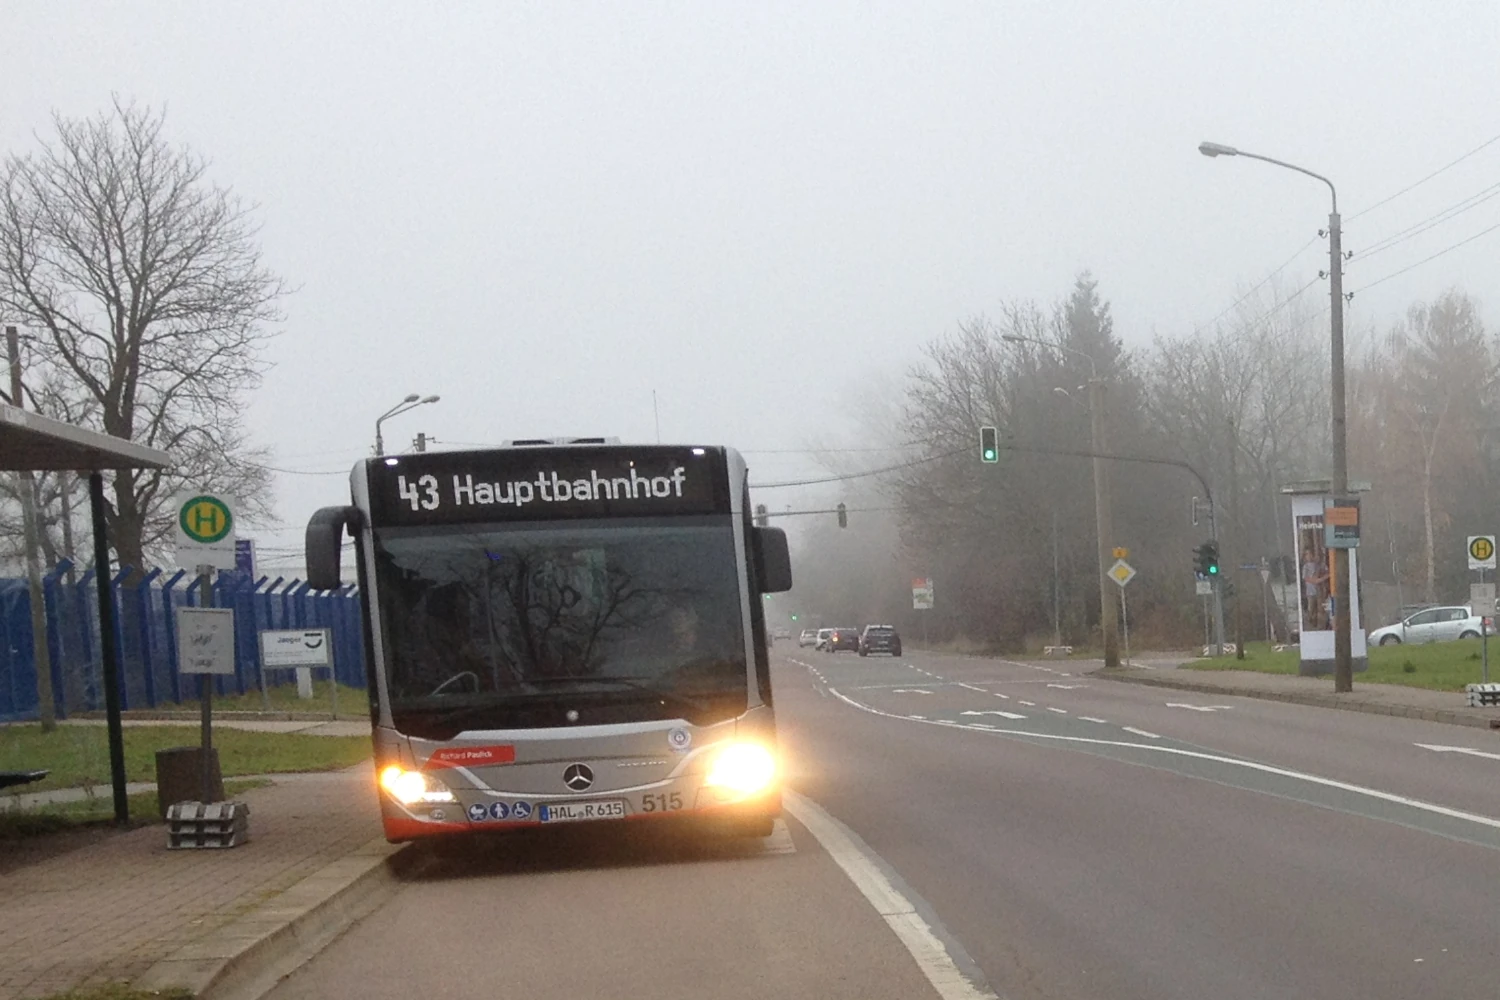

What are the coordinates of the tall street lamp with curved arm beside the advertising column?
(1199, 142, 1355, 691)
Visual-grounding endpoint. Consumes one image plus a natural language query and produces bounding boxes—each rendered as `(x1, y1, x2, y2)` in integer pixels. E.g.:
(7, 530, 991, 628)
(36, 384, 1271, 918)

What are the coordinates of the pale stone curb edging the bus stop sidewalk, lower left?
(134, 837, 417, 1000)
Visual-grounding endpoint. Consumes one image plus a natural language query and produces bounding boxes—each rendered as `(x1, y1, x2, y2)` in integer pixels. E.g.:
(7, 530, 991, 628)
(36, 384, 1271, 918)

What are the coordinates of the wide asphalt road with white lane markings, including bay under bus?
(272, 646, 1500, 1000)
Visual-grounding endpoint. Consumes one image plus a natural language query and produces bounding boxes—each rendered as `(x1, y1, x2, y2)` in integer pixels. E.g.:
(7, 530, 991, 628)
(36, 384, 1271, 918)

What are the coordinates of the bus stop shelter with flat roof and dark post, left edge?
(0, 403, 171, 823)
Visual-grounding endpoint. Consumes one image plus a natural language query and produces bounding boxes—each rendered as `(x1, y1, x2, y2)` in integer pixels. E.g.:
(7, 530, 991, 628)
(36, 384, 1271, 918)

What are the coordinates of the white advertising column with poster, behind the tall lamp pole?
(1289, 490, 1367, 675)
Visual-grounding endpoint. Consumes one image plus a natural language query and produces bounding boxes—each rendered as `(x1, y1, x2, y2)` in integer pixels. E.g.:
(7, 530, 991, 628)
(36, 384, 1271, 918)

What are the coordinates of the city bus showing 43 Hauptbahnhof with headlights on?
(308, 438, 792, 843)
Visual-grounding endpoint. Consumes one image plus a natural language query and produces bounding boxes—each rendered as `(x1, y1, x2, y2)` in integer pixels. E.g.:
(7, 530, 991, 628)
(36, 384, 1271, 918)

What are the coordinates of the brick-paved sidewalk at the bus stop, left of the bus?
(0, 763, 384, 1000)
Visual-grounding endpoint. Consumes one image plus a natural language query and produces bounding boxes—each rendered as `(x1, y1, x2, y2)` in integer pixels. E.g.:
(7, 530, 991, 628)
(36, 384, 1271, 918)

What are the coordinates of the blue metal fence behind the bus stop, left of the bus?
(0, 562, 365, 723)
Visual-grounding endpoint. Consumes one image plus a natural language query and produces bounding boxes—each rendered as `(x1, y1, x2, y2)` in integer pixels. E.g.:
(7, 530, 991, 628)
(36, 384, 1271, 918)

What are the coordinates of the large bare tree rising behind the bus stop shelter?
(0, 100, 285, 567)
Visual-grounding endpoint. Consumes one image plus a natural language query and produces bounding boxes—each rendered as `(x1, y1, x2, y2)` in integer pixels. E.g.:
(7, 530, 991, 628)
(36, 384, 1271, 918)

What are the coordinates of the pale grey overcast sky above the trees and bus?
(0, 0, 1500, 566)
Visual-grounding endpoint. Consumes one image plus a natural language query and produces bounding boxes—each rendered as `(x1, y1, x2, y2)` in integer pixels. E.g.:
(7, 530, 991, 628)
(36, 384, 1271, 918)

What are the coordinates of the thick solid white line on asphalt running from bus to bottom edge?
(782, 789, 998, 1000)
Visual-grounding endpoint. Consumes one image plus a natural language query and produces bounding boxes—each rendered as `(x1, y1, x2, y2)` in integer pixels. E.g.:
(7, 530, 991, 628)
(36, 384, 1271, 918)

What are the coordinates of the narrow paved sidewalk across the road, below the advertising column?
(1091, 667, 1500, 729)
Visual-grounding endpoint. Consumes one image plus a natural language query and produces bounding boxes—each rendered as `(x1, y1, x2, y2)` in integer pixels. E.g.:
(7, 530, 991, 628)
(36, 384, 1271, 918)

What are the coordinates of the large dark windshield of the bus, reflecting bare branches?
(375, 516, 747, 739)
